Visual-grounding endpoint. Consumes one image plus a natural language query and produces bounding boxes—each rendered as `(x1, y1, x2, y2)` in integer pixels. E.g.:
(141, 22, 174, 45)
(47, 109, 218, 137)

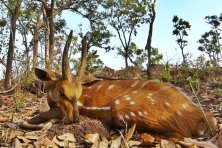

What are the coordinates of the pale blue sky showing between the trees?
(64, 0, 222, 69)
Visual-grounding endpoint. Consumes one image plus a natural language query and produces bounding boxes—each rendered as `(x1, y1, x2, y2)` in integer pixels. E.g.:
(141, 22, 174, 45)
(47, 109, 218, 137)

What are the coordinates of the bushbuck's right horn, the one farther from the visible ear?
(77, 36, 88, 80)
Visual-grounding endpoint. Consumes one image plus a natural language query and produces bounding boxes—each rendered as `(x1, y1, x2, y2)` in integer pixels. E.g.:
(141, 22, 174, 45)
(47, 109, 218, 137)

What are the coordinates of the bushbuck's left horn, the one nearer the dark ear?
(62, 30, 73, 81)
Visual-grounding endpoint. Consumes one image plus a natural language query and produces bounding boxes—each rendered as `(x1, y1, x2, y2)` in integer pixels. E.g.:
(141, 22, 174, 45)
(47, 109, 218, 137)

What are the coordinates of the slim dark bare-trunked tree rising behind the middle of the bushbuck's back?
(145, 0, 156, 77)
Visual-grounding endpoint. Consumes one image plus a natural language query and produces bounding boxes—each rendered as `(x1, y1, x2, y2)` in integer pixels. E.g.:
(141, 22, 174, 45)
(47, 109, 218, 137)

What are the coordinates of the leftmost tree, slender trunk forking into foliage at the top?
(2, 0, 22, 89)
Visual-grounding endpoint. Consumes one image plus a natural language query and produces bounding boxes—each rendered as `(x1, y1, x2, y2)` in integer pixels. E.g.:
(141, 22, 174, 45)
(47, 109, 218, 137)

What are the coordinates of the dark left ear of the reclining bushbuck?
(35, 68, 56, 81)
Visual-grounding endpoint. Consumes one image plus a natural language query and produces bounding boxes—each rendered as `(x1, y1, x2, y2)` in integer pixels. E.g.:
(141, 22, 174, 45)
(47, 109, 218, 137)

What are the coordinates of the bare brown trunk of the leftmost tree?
(5, 0, 22, 89)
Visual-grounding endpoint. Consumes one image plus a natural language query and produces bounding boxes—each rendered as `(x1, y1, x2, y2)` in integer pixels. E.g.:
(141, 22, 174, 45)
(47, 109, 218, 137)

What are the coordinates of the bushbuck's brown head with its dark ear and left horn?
(35, 31, 82, 123)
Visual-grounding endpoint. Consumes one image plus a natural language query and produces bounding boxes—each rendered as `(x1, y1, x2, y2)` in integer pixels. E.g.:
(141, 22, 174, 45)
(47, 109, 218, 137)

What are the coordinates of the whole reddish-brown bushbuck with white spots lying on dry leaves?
(22, 31, 216, 138)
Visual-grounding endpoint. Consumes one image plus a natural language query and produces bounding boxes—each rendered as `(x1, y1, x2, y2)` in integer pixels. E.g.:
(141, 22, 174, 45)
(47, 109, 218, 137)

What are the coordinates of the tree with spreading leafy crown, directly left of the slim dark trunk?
(103, 0, 148, 67)
